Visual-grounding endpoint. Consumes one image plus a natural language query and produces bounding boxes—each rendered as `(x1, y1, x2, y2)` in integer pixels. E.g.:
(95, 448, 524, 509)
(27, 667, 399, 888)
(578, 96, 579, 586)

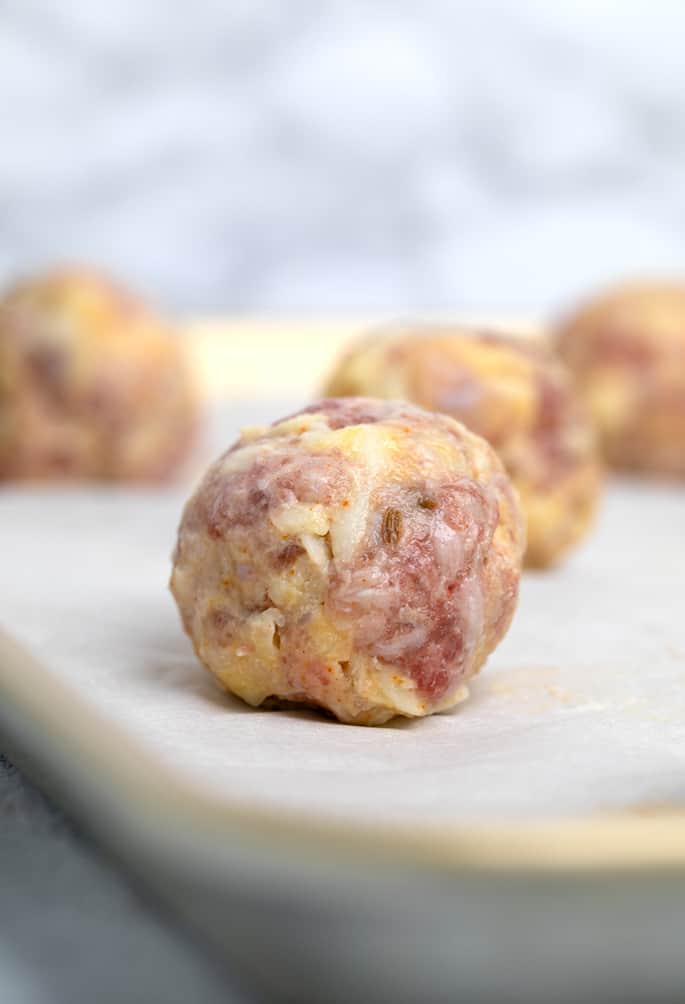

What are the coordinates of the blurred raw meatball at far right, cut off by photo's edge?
(558, 284, 685, 477)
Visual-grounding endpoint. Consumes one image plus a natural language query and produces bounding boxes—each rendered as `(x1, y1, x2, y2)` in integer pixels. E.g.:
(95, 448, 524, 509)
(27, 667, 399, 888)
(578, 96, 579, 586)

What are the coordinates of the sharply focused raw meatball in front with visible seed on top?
(171, 400, 524, 725)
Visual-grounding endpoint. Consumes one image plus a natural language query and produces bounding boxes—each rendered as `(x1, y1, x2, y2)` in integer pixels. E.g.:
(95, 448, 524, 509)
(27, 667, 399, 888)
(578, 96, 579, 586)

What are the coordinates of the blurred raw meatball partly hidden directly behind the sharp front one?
(325, 325, 601, 567)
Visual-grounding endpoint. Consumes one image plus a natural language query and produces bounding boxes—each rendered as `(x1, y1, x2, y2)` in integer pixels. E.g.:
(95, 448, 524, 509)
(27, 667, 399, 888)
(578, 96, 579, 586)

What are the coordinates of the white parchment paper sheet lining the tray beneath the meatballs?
(0, 453, 685, 820)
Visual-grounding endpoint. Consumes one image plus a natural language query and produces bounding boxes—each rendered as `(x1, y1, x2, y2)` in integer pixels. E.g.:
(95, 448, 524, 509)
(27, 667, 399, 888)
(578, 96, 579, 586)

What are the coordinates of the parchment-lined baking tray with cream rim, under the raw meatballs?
(0, 325, 685, 1002)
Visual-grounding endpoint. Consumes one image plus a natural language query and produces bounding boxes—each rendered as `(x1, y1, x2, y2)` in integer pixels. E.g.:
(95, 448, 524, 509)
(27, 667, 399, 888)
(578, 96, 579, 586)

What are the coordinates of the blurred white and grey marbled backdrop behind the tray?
(0, 0, 685, 314)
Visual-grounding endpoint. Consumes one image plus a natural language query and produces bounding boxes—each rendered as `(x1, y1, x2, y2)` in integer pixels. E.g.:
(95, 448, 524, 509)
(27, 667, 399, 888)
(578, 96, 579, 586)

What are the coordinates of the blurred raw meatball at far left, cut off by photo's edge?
(0, 270, 197, 480)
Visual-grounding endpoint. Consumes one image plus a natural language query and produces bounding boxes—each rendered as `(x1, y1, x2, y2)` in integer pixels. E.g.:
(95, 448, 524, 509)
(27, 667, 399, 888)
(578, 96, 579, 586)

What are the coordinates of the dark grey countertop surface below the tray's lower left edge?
(0, 755, 247, 1004)
